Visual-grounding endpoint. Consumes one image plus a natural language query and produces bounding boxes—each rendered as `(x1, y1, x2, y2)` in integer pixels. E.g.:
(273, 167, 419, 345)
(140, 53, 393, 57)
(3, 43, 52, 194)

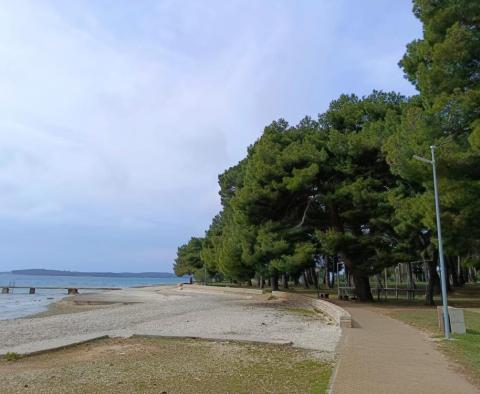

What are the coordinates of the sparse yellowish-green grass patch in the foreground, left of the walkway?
(0, 337, 332, 394)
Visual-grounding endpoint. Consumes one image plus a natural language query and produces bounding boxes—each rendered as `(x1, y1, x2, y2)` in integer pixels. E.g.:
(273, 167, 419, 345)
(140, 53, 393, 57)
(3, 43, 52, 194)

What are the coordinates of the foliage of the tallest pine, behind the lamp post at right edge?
(384, 0, 480, 264)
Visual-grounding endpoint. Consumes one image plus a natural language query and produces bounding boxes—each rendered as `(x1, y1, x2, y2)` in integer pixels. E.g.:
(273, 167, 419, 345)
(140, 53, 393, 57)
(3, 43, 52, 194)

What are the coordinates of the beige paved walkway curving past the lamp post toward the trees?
(332, 303, 480, 394)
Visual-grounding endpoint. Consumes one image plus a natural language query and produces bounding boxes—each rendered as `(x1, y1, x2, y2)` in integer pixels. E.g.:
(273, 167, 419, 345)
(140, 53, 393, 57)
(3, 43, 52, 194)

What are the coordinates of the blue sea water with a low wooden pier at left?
(0, 273, 187, 320)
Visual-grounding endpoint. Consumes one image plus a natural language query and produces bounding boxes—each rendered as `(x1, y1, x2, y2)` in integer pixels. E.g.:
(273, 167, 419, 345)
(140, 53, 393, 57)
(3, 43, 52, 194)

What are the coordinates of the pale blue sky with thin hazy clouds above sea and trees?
(0, 0, 422, 272)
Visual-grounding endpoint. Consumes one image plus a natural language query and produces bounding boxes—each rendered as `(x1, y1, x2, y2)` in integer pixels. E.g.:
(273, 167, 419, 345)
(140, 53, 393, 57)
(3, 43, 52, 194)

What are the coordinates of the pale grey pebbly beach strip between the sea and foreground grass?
(0, 286, 340, 358)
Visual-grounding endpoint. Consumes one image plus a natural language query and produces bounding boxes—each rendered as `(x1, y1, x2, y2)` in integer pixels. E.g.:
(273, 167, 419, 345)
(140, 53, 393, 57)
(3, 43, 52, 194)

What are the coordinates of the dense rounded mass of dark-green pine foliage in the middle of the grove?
(185, 92, 405, 296)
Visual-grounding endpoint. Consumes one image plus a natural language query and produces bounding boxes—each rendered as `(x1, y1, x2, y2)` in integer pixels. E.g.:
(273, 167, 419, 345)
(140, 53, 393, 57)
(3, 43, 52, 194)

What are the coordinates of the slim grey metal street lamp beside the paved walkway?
(413, 145, 450, 339)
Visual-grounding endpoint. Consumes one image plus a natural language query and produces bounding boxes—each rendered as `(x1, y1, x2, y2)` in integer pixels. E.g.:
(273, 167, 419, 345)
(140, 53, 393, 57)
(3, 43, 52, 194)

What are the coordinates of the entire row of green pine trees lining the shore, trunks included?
(174, 0, 480, 304)
